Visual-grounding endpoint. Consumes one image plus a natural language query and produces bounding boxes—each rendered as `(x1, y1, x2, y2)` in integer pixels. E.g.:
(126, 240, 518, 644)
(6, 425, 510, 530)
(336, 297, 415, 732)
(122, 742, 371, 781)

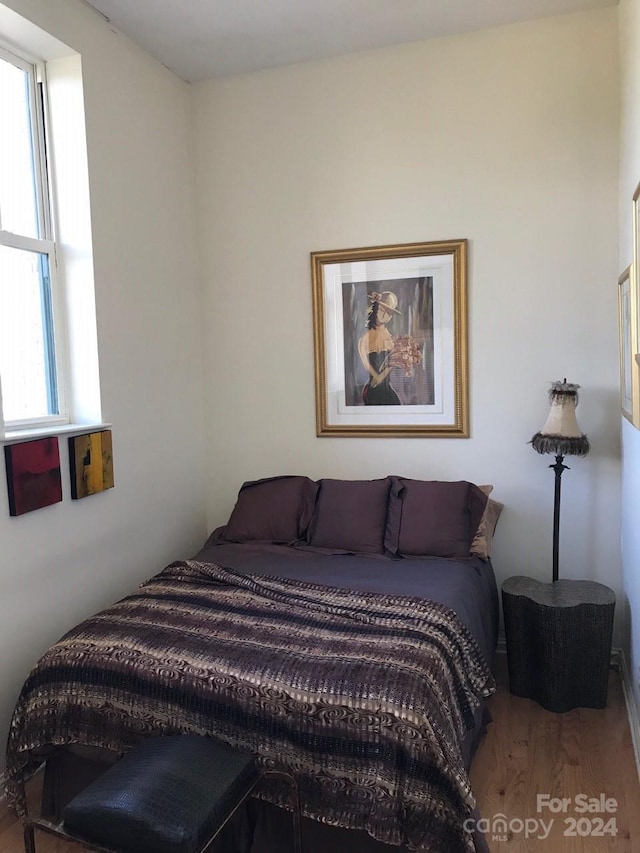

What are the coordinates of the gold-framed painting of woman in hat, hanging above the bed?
(311, 240, 469, 438)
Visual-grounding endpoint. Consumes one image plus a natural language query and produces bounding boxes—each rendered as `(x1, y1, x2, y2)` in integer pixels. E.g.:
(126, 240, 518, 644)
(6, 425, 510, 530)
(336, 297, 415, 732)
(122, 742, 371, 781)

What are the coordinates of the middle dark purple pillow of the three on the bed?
(307, 477, 391, 554)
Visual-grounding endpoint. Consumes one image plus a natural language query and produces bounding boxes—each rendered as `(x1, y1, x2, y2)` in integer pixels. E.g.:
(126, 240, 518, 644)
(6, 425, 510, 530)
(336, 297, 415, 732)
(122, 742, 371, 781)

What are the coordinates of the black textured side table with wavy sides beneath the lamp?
(502, 577, 616, 712)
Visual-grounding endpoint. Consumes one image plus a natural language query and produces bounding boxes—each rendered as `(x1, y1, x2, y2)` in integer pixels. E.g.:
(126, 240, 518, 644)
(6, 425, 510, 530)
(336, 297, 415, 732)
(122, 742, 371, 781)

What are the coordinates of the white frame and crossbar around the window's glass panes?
(0, 42, 70, 437)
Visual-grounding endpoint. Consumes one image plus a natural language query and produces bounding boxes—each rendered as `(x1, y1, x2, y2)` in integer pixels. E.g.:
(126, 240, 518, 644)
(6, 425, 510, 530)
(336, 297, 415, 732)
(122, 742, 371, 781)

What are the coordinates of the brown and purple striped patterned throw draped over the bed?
(7, 561, 494, 853)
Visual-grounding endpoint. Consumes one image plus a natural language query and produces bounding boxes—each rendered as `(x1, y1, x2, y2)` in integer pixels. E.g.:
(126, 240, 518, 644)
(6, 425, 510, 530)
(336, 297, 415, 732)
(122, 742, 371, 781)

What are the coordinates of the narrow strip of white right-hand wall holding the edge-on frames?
(618, 0, 640, 707)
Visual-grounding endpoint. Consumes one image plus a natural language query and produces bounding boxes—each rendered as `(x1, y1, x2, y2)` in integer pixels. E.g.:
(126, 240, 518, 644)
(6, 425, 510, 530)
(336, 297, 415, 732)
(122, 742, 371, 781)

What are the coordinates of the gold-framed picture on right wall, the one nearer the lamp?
(618, 264, 640, 428)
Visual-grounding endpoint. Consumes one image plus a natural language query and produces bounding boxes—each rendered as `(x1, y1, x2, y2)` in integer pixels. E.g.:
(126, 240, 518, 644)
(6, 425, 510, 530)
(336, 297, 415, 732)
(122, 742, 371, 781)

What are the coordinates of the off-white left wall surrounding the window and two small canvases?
(0, 0, 206, 767)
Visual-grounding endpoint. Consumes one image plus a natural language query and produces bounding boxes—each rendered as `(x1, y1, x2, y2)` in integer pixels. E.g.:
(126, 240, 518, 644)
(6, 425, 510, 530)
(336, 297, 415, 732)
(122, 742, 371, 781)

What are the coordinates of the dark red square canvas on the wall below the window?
(4, 438, 62, 515)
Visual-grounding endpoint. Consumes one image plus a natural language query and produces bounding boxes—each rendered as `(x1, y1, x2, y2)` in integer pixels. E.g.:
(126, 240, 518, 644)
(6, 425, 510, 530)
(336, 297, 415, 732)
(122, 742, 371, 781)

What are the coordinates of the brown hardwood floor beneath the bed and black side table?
(0, 656, 640, 853)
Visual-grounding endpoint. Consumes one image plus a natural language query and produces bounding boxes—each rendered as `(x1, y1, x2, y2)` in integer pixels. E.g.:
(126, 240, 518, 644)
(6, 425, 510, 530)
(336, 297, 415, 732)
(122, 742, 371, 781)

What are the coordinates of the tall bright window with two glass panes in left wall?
(0, 43, 69, 430)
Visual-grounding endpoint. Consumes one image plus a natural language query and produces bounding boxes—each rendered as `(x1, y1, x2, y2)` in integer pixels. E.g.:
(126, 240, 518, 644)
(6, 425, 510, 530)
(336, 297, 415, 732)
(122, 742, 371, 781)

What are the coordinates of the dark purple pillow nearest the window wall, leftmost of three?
(223, 477, 318, 543)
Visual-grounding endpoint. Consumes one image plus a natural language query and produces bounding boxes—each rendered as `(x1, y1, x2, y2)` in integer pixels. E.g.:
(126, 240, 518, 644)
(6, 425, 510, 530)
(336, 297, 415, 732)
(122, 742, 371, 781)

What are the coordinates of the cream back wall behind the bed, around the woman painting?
(193, 8, 620, 620)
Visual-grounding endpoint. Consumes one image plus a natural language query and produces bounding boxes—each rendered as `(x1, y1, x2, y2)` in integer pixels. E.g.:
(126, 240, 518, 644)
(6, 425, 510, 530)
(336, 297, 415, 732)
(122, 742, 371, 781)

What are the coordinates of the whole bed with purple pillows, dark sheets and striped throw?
(2, 477, 500, 853)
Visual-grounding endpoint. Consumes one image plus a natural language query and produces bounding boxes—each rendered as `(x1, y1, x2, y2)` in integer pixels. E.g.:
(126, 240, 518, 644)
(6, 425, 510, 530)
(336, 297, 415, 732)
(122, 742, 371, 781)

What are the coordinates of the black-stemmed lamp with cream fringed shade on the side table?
(530, 379, 591, 581)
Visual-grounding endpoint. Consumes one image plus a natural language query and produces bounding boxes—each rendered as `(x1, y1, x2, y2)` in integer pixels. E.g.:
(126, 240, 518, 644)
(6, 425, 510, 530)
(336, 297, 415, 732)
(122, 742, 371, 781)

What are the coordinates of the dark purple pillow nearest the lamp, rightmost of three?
(385, 477, 487, 557)
